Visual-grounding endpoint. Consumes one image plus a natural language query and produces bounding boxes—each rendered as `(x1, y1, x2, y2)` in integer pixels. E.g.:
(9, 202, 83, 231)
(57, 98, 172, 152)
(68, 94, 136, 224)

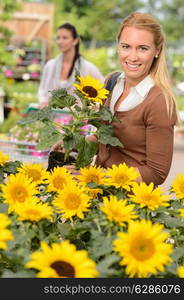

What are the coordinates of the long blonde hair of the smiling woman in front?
(117, 12, 179, 122)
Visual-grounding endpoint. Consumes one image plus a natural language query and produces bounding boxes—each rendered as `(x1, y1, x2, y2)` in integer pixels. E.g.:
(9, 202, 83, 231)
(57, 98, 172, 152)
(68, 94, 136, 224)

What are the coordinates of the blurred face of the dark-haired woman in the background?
(56, 28, 78, 53)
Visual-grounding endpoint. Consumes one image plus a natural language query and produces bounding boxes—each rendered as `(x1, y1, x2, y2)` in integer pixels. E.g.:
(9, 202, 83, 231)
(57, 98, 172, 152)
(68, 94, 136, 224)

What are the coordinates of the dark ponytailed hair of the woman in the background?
(57, 23, 80, 78)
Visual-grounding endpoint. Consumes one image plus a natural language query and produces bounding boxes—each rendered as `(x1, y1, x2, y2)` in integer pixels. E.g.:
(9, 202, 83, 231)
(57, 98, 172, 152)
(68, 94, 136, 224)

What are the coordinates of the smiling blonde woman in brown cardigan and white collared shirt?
(95, 12, 178, 185)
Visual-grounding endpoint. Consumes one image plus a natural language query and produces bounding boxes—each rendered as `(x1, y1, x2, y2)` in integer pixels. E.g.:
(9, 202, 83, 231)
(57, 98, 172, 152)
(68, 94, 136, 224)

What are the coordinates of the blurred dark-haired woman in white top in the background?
(38, 23, 104, 108)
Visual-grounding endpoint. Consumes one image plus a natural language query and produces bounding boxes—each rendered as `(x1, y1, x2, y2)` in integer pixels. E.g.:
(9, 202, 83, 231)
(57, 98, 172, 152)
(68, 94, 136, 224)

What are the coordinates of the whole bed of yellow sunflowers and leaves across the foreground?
(0, 152, 184, 278)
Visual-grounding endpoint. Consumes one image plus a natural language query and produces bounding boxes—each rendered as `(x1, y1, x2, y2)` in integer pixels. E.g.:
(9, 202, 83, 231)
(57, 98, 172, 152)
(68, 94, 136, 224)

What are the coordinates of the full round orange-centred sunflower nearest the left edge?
(0, 173, 38, 213)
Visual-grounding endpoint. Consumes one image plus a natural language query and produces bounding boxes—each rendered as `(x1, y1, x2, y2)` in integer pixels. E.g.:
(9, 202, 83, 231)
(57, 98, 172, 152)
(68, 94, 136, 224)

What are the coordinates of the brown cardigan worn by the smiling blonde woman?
(96, 86, 176, 185)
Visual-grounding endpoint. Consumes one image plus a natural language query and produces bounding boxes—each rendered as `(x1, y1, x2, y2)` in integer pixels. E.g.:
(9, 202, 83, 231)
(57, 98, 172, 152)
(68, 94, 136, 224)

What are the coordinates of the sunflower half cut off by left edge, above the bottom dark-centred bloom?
(0, 213, 13, 250)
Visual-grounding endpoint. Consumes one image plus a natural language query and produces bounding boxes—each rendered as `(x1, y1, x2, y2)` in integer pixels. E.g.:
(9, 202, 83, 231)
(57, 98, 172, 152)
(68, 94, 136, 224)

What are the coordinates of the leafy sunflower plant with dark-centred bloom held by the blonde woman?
(20, 73, 123, 169)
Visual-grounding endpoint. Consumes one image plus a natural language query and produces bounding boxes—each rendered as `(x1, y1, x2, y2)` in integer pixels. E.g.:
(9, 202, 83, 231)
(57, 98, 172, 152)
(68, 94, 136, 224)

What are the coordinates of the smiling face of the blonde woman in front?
(118, 26, 159, 85)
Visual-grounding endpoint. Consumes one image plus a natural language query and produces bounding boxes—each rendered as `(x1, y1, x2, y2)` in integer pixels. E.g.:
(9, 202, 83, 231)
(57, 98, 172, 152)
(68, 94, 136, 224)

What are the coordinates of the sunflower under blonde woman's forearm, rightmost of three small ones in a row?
(106, 163, 139, 191)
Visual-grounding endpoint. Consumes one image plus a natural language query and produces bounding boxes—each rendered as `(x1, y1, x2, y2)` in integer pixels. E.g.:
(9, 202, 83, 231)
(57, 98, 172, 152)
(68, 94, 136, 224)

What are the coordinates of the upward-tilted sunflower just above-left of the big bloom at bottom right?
(100, 195, 138, 226)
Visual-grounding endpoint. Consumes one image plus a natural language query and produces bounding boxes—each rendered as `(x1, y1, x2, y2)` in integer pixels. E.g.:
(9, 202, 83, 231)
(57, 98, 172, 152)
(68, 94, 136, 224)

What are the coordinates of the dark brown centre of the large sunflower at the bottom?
(50, 260, 75, 278)
